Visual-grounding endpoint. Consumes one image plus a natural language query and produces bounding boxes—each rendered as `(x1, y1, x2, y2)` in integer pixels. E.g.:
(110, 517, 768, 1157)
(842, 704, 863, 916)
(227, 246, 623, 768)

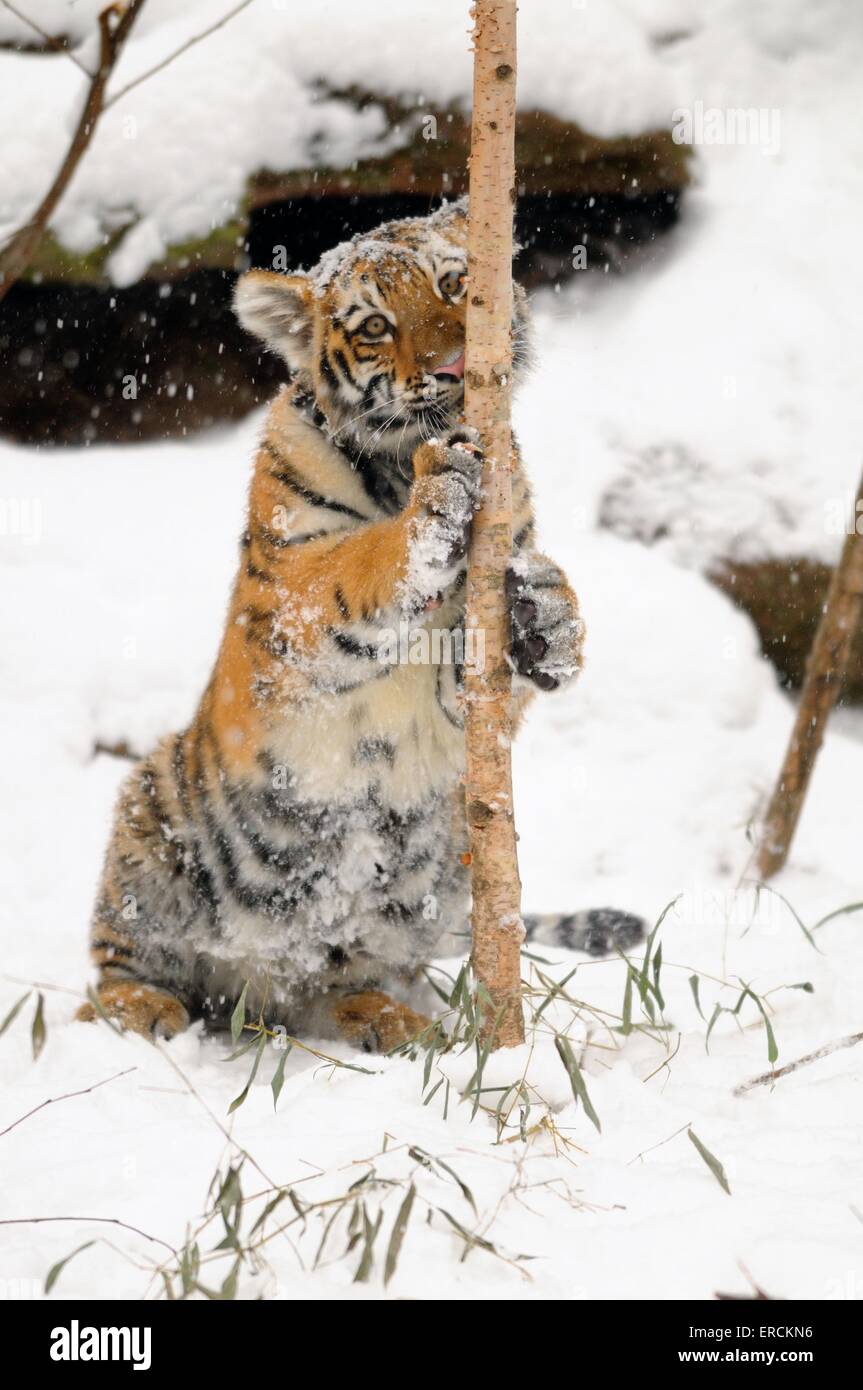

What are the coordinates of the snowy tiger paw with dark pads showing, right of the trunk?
(506, 553, 584, 691)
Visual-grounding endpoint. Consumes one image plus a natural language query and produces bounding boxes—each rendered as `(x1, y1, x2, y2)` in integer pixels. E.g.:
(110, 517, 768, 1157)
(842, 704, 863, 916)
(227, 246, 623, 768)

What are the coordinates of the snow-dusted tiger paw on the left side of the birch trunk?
(404, 425, 482, 607)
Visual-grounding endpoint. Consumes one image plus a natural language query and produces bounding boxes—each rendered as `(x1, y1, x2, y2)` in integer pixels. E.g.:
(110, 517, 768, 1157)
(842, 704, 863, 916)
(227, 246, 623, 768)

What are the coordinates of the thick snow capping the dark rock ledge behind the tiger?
(0, 0, 674, 285)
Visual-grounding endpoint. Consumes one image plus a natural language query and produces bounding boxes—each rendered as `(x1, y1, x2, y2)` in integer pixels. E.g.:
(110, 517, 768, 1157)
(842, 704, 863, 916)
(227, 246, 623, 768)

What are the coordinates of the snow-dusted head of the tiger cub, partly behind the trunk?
(235, 203, 527, 460)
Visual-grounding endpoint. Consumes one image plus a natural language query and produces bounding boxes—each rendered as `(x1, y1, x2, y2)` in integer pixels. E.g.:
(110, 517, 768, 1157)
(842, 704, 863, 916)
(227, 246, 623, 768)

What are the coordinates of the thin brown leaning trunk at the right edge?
(757, 478, 863, 878)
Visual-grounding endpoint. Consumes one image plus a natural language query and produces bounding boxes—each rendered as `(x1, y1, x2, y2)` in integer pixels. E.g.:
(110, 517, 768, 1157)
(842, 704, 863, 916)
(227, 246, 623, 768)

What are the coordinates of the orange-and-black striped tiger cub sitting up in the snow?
(79, 203, 641, 1049)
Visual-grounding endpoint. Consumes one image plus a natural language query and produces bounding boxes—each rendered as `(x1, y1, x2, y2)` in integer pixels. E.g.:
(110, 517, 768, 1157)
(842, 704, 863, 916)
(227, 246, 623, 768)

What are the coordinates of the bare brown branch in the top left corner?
(0, 0, 145, 300)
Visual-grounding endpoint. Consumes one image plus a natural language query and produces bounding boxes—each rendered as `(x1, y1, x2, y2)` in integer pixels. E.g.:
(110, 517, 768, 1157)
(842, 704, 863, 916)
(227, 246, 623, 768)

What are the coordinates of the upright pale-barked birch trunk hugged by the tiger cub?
(464, 0, 524, 1047)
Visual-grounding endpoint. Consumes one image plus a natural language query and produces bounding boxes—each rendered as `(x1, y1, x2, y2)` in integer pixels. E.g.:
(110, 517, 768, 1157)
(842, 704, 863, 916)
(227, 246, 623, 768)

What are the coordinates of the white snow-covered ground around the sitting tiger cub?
(0, 3, 863, 1300)
